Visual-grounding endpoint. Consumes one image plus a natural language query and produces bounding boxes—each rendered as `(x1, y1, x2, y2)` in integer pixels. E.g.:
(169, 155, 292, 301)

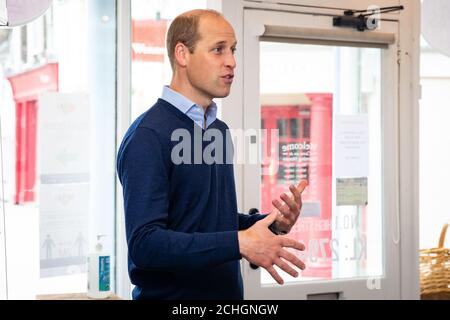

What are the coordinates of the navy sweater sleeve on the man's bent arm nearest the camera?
(117, 128, 241, 271)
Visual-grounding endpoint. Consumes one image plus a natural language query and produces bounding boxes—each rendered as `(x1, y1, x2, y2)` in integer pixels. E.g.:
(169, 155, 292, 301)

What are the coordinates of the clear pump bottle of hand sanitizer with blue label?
(87, 234, 111, 299)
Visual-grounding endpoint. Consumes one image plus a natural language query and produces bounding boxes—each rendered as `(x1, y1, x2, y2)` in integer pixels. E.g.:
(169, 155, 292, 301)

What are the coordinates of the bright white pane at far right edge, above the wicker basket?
(420, 41, 450, 249)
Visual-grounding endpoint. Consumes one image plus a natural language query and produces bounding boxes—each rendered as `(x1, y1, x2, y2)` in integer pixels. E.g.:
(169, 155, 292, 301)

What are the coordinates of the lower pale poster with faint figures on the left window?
(39, 183, 89, 278)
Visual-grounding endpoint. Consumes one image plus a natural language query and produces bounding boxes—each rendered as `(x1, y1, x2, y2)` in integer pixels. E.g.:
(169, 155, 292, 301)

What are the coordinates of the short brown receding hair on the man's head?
(166, 9, 222, 71)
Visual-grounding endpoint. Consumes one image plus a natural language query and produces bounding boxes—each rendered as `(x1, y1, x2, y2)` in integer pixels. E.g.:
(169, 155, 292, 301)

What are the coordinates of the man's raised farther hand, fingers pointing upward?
(272, 180, 308, 233)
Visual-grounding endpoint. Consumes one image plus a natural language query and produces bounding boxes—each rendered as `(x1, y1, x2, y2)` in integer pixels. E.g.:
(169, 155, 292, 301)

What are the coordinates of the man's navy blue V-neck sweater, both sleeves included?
(117, 99, 264, 299)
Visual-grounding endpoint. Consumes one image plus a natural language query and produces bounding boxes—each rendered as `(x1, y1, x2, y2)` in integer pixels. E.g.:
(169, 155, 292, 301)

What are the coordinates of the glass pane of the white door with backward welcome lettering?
(258, 41, 384, 285)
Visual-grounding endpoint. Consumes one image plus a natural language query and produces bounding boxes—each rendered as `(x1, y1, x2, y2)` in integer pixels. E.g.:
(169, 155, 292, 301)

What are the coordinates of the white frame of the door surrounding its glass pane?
(243, 9, 399, 299)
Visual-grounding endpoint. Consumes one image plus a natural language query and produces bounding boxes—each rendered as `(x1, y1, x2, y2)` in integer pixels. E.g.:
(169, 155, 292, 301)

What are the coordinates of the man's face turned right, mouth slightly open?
(186, 15, 236, 100)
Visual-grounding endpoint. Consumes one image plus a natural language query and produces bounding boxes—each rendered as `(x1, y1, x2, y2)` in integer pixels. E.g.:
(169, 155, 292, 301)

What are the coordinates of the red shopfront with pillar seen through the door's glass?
(261, 93, 333, 279)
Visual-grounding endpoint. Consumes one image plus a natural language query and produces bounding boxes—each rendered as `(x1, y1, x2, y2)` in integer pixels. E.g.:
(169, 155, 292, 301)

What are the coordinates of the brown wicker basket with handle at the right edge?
(420, 224, 450, 300)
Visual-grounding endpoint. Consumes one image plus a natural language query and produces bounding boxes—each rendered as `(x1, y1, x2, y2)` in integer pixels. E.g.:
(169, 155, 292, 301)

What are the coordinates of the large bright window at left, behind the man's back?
(0, 0, 116, 299)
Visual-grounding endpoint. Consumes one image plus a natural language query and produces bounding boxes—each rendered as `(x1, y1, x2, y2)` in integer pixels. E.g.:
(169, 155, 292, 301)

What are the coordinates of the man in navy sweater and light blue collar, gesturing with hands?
(117, 10, 305, 299)
